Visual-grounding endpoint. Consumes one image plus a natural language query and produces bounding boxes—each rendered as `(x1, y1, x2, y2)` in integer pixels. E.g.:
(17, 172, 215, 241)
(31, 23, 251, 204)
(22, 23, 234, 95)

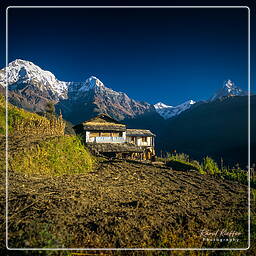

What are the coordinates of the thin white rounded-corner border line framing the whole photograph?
(5, 6, 251, 251)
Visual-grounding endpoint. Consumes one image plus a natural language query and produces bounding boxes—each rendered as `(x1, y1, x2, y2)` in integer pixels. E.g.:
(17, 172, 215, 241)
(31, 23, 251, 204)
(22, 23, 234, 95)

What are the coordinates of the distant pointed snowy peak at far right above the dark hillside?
(210, 80, 248, 101)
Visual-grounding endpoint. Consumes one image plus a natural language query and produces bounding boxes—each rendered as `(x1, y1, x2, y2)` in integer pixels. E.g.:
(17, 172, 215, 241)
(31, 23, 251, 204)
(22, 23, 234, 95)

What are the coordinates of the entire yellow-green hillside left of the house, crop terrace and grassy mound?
(0, 95, 93, 175)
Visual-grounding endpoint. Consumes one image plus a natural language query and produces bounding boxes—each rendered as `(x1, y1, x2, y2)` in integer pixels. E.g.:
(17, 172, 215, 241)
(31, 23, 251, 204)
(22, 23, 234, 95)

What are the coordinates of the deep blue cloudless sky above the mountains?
(1, 8, 248, 105)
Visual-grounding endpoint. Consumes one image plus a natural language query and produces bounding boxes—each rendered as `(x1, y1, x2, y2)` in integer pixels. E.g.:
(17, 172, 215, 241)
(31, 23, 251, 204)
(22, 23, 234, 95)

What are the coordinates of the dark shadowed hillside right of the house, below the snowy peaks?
(159, 96, 256, 165)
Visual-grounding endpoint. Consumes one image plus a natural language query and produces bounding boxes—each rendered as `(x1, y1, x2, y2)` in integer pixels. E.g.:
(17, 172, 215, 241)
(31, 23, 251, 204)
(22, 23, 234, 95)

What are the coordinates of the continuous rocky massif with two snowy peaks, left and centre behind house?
(0, 59, 152, 123)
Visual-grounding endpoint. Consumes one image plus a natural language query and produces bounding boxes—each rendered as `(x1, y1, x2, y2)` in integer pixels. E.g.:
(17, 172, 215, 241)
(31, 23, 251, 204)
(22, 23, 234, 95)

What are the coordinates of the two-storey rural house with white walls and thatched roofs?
(73, 114, 155, 160)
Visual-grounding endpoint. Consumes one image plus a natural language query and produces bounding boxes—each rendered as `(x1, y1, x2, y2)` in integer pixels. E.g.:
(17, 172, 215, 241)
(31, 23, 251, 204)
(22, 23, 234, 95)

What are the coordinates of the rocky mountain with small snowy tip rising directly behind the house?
(59, 76, 154, 123)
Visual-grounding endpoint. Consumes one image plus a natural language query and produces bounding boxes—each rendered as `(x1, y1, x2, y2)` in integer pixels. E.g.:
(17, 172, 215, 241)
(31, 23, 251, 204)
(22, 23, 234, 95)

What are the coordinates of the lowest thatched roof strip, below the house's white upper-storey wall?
(86, 143, 143, 153)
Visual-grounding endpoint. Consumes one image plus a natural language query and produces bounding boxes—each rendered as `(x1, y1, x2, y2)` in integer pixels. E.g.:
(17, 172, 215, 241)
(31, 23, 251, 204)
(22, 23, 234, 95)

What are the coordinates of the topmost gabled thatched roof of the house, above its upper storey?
(74, 114, 126, 131)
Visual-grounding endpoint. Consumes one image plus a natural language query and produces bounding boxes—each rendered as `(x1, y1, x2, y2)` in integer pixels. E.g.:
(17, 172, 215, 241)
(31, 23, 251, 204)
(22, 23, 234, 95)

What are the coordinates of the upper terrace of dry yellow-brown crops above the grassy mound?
(0, 95, 65, 135)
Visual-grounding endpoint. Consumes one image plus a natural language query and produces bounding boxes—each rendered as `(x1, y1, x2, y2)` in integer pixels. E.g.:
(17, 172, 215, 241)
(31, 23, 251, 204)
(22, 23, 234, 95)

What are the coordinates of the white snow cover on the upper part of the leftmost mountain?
(0, 59, 69, 99)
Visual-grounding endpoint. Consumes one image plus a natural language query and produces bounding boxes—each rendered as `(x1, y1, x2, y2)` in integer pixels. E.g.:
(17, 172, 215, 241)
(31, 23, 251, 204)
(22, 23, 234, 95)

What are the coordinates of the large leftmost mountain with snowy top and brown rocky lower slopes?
(0, 59, 68, 112)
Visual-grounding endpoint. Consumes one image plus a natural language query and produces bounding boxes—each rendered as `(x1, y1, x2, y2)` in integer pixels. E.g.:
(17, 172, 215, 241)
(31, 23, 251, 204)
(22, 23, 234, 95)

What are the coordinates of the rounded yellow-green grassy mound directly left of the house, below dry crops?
(9, 136, 95, 175)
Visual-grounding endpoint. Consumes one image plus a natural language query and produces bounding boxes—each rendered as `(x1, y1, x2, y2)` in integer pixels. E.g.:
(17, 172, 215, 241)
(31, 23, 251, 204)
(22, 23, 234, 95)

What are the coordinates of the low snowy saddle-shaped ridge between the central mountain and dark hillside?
(154, 100, 196, 119)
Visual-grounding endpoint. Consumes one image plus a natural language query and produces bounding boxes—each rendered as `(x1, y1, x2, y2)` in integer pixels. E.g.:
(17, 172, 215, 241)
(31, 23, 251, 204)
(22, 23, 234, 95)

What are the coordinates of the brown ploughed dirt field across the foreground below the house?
(0, 136, 250, 252)
